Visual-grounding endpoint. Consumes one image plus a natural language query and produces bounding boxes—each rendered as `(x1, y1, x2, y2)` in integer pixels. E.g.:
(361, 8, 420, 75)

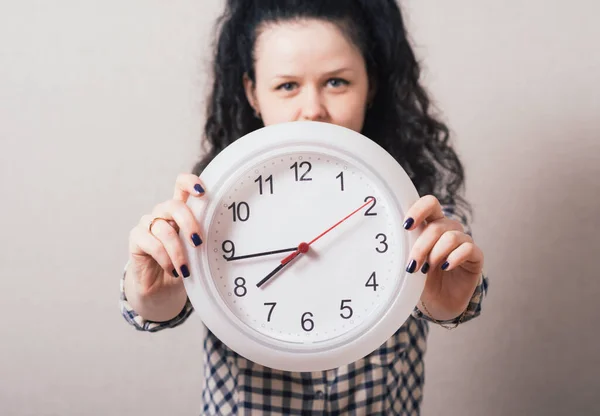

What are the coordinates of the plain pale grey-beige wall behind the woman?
(0, 0, 600, 415)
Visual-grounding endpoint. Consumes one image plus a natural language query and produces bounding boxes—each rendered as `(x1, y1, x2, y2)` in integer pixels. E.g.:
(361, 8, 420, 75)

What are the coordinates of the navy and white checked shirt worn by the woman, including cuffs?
(121, 207, 488, 415)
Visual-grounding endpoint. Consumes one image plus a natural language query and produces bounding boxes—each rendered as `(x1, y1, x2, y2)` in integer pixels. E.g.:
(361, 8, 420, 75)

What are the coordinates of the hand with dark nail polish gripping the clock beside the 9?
(128, 174, 204, 297)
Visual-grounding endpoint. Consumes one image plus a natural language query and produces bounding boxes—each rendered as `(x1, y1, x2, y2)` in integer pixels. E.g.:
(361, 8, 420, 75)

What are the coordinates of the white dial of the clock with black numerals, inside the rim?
(207, 151, 404, 346)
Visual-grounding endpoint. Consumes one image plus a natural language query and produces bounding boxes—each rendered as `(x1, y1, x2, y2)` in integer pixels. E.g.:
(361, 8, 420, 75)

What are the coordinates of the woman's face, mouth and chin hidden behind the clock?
(244, 19, 370, 132)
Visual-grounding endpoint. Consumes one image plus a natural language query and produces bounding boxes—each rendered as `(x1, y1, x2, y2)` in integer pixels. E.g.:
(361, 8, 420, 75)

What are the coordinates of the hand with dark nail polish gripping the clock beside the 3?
(404, 195, 483, 321)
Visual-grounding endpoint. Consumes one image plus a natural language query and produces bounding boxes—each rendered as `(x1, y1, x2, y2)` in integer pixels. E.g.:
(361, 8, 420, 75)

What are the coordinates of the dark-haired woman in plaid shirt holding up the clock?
(122, 0, 487, 415)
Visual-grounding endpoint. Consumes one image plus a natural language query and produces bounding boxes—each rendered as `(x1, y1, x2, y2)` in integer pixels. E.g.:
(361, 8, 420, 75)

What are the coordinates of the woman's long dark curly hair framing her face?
(193, 0, 469, 210)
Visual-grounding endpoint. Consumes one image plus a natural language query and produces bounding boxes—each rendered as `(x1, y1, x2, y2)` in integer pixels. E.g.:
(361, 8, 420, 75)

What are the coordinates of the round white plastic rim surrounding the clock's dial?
(182, 121, 425, 371)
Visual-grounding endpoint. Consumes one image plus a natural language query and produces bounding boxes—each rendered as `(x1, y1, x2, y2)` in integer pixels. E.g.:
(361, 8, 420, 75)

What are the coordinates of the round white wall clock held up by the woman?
(184, 121, 425, 371)
